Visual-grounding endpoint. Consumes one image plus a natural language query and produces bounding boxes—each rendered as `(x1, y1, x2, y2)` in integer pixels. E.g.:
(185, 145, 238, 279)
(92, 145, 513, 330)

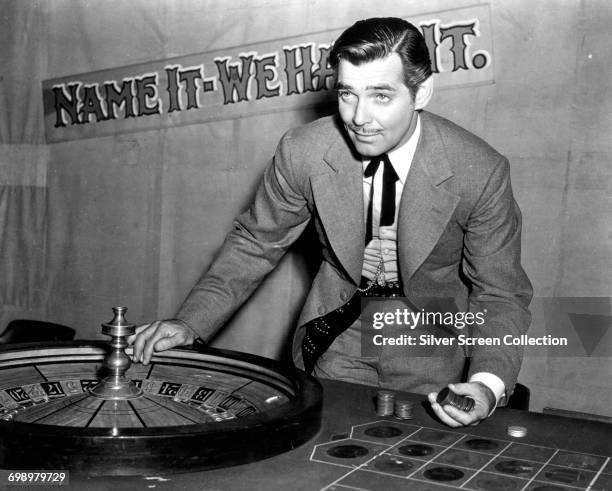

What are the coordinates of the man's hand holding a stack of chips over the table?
(427, 382, 497, 428)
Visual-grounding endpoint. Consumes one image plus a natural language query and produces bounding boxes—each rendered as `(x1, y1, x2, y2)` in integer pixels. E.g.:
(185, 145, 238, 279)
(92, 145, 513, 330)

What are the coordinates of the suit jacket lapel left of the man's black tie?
(310, 133, 365, 284)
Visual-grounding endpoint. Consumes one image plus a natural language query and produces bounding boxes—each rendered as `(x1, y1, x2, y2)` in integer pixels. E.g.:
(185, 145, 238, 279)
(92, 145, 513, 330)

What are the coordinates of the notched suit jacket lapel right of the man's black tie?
(398, 112, 460, 282)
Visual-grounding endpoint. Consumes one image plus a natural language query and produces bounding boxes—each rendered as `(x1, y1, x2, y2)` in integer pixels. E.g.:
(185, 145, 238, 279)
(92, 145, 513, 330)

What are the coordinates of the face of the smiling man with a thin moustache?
(337, 53, 417, 157)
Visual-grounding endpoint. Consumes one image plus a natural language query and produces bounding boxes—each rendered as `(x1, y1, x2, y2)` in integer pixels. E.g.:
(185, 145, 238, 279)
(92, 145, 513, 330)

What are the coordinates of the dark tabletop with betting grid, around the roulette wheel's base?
(3, 370, 612, 491)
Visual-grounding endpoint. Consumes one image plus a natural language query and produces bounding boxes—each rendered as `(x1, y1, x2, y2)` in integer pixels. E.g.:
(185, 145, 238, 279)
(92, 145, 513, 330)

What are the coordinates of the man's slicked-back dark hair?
(330, 17, 431, 96)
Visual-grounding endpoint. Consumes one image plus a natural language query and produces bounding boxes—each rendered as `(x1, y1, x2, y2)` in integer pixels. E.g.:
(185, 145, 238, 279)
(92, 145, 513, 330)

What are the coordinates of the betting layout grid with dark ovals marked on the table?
(310, 420, 612, 491)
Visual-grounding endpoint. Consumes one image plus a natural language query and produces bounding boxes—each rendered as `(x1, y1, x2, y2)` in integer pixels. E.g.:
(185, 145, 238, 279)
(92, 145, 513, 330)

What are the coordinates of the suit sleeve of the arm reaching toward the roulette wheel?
(176, 136, 310, 340)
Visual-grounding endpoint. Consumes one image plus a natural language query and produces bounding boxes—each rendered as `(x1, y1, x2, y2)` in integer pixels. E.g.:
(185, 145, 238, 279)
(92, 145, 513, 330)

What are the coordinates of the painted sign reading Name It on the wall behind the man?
(43, 5, 493, 143)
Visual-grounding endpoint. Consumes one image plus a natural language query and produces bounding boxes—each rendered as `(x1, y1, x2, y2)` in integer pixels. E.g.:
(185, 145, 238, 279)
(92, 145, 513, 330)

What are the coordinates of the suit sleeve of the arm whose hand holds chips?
(462, 158, 532, 394)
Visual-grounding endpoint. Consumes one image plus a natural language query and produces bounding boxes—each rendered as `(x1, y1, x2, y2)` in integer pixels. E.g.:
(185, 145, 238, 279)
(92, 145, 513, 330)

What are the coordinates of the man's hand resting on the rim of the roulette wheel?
(128, 319, 198, 365)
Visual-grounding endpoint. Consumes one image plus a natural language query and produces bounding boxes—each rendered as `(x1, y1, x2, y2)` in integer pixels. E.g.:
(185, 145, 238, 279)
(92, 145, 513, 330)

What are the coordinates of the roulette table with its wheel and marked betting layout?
(0, 310, 612, 491)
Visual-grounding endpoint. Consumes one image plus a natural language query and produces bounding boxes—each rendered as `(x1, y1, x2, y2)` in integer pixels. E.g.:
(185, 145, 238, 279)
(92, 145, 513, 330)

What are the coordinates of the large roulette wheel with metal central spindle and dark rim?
(0, 307, 322, 475)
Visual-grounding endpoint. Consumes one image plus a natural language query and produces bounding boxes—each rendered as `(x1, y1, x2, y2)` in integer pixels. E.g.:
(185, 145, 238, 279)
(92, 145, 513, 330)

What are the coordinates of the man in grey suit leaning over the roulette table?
(132, 18, 531, 426)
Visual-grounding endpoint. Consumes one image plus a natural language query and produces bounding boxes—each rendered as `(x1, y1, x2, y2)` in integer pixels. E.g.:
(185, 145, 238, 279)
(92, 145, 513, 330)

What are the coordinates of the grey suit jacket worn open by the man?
(177, 111, 532, 392)
